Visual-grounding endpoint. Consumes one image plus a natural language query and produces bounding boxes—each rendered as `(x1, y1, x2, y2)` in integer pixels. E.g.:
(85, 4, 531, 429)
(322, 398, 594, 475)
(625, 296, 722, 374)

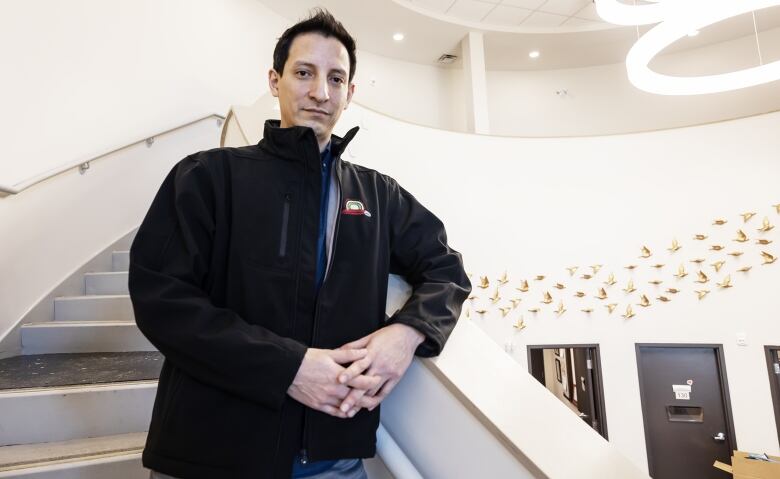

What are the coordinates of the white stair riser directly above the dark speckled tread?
(21, 321, 156, 355)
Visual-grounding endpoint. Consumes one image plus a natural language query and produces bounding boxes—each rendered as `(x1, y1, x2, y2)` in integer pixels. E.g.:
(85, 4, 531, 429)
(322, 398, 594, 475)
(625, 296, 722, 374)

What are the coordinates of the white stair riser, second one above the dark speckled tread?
(54, 294, 135, 321)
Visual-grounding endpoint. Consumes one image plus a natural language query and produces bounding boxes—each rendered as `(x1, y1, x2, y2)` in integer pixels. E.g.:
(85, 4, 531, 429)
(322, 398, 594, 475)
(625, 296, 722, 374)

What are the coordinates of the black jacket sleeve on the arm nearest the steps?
(129, 157, 306, 409)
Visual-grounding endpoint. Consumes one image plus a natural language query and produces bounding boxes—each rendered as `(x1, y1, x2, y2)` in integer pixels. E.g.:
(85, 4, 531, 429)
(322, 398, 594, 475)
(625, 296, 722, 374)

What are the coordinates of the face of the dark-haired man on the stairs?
(268, 33, 355, 144)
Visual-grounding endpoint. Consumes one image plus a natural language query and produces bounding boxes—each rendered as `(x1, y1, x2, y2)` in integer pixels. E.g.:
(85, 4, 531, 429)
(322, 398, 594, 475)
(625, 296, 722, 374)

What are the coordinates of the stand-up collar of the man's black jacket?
(258, 120, 360, 165)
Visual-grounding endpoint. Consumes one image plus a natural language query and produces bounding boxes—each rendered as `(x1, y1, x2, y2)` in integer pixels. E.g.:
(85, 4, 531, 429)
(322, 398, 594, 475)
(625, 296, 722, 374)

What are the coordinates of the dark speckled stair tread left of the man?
(0, 351, 164, 390)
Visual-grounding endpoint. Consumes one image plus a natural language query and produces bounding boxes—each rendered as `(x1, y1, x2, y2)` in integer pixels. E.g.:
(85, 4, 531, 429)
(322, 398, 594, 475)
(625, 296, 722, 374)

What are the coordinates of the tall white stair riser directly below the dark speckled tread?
(0, 381, 157, 446)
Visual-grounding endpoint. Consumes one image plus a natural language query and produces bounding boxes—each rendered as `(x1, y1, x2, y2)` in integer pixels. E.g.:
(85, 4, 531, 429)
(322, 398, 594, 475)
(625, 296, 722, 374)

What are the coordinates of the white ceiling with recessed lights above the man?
(258, 0, 780, 70)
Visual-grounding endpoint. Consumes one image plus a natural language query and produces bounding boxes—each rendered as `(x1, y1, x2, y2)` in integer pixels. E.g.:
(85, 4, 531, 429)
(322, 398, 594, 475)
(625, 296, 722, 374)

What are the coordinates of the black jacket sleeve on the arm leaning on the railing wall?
(387, 181, 471, 357)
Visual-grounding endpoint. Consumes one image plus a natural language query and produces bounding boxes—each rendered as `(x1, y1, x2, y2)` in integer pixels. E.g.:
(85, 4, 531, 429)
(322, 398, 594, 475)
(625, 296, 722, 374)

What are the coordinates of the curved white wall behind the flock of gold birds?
(340, 103, 780, 474)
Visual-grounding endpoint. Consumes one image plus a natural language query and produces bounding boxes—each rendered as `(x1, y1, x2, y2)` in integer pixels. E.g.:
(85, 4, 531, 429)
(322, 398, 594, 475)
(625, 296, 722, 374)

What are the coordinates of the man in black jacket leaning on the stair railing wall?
(130, 11, 470, 479)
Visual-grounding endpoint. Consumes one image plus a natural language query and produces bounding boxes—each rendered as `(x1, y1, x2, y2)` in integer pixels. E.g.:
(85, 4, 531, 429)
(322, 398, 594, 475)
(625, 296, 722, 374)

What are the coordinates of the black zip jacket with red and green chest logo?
(129, 121, 471, 479)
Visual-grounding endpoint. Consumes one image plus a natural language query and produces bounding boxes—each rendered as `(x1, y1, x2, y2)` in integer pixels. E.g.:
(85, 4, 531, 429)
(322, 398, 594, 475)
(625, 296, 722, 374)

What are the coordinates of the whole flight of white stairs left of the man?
(0, 251, 157, 479)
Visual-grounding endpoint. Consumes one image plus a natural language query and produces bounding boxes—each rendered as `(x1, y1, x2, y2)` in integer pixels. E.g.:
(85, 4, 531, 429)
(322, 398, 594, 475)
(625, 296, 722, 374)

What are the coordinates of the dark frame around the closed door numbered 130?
(635, 343, 739, 476)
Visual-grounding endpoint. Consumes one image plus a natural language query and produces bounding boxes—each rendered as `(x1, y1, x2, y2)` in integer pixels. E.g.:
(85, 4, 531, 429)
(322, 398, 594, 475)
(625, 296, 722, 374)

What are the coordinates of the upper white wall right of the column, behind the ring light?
(487, 28, 780, 137)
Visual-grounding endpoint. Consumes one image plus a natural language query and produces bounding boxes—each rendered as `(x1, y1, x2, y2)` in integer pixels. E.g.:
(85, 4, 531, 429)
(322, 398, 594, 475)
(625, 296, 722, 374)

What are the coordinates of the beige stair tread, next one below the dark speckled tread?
(0, 432, 146, 471)
